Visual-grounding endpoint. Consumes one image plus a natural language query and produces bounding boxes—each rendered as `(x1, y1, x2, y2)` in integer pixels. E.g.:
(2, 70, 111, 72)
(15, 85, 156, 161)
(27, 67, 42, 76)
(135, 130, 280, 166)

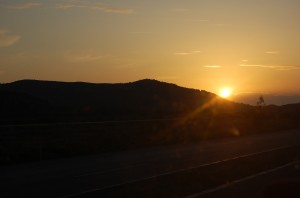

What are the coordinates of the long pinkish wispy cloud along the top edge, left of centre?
(55, 1, 133, 14)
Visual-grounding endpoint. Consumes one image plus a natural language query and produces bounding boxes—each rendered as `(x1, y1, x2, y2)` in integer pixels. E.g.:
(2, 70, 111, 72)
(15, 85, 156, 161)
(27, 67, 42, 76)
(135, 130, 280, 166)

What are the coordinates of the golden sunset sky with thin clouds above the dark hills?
(0, 0, 300, 104)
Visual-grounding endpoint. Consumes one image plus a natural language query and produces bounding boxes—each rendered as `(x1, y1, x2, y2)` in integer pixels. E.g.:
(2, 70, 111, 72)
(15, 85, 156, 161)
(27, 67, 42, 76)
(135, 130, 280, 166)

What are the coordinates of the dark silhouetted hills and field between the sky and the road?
(0, 79, 300, 164)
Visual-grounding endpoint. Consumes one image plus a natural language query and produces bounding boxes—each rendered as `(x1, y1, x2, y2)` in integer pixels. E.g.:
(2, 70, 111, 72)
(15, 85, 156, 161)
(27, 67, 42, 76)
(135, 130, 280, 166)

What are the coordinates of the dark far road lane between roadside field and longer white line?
(0, 130, 300, 198)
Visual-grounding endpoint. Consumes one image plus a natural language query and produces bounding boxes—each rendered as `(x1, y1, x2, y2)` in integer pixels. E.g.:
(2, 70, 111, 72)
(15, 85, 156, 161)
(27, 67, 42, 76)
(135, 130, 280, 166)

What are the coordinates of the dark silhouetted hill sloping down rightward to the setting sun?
(0, 79, 233, 120)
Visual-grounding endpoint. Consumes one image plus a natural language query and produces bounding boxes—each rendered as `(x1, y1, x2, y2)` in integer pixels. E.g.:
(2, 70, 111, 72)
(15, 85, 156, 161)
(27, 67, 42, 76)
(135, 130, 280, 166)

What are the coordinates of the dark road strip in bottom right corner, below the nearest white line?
(192, 161, 300, 198)
